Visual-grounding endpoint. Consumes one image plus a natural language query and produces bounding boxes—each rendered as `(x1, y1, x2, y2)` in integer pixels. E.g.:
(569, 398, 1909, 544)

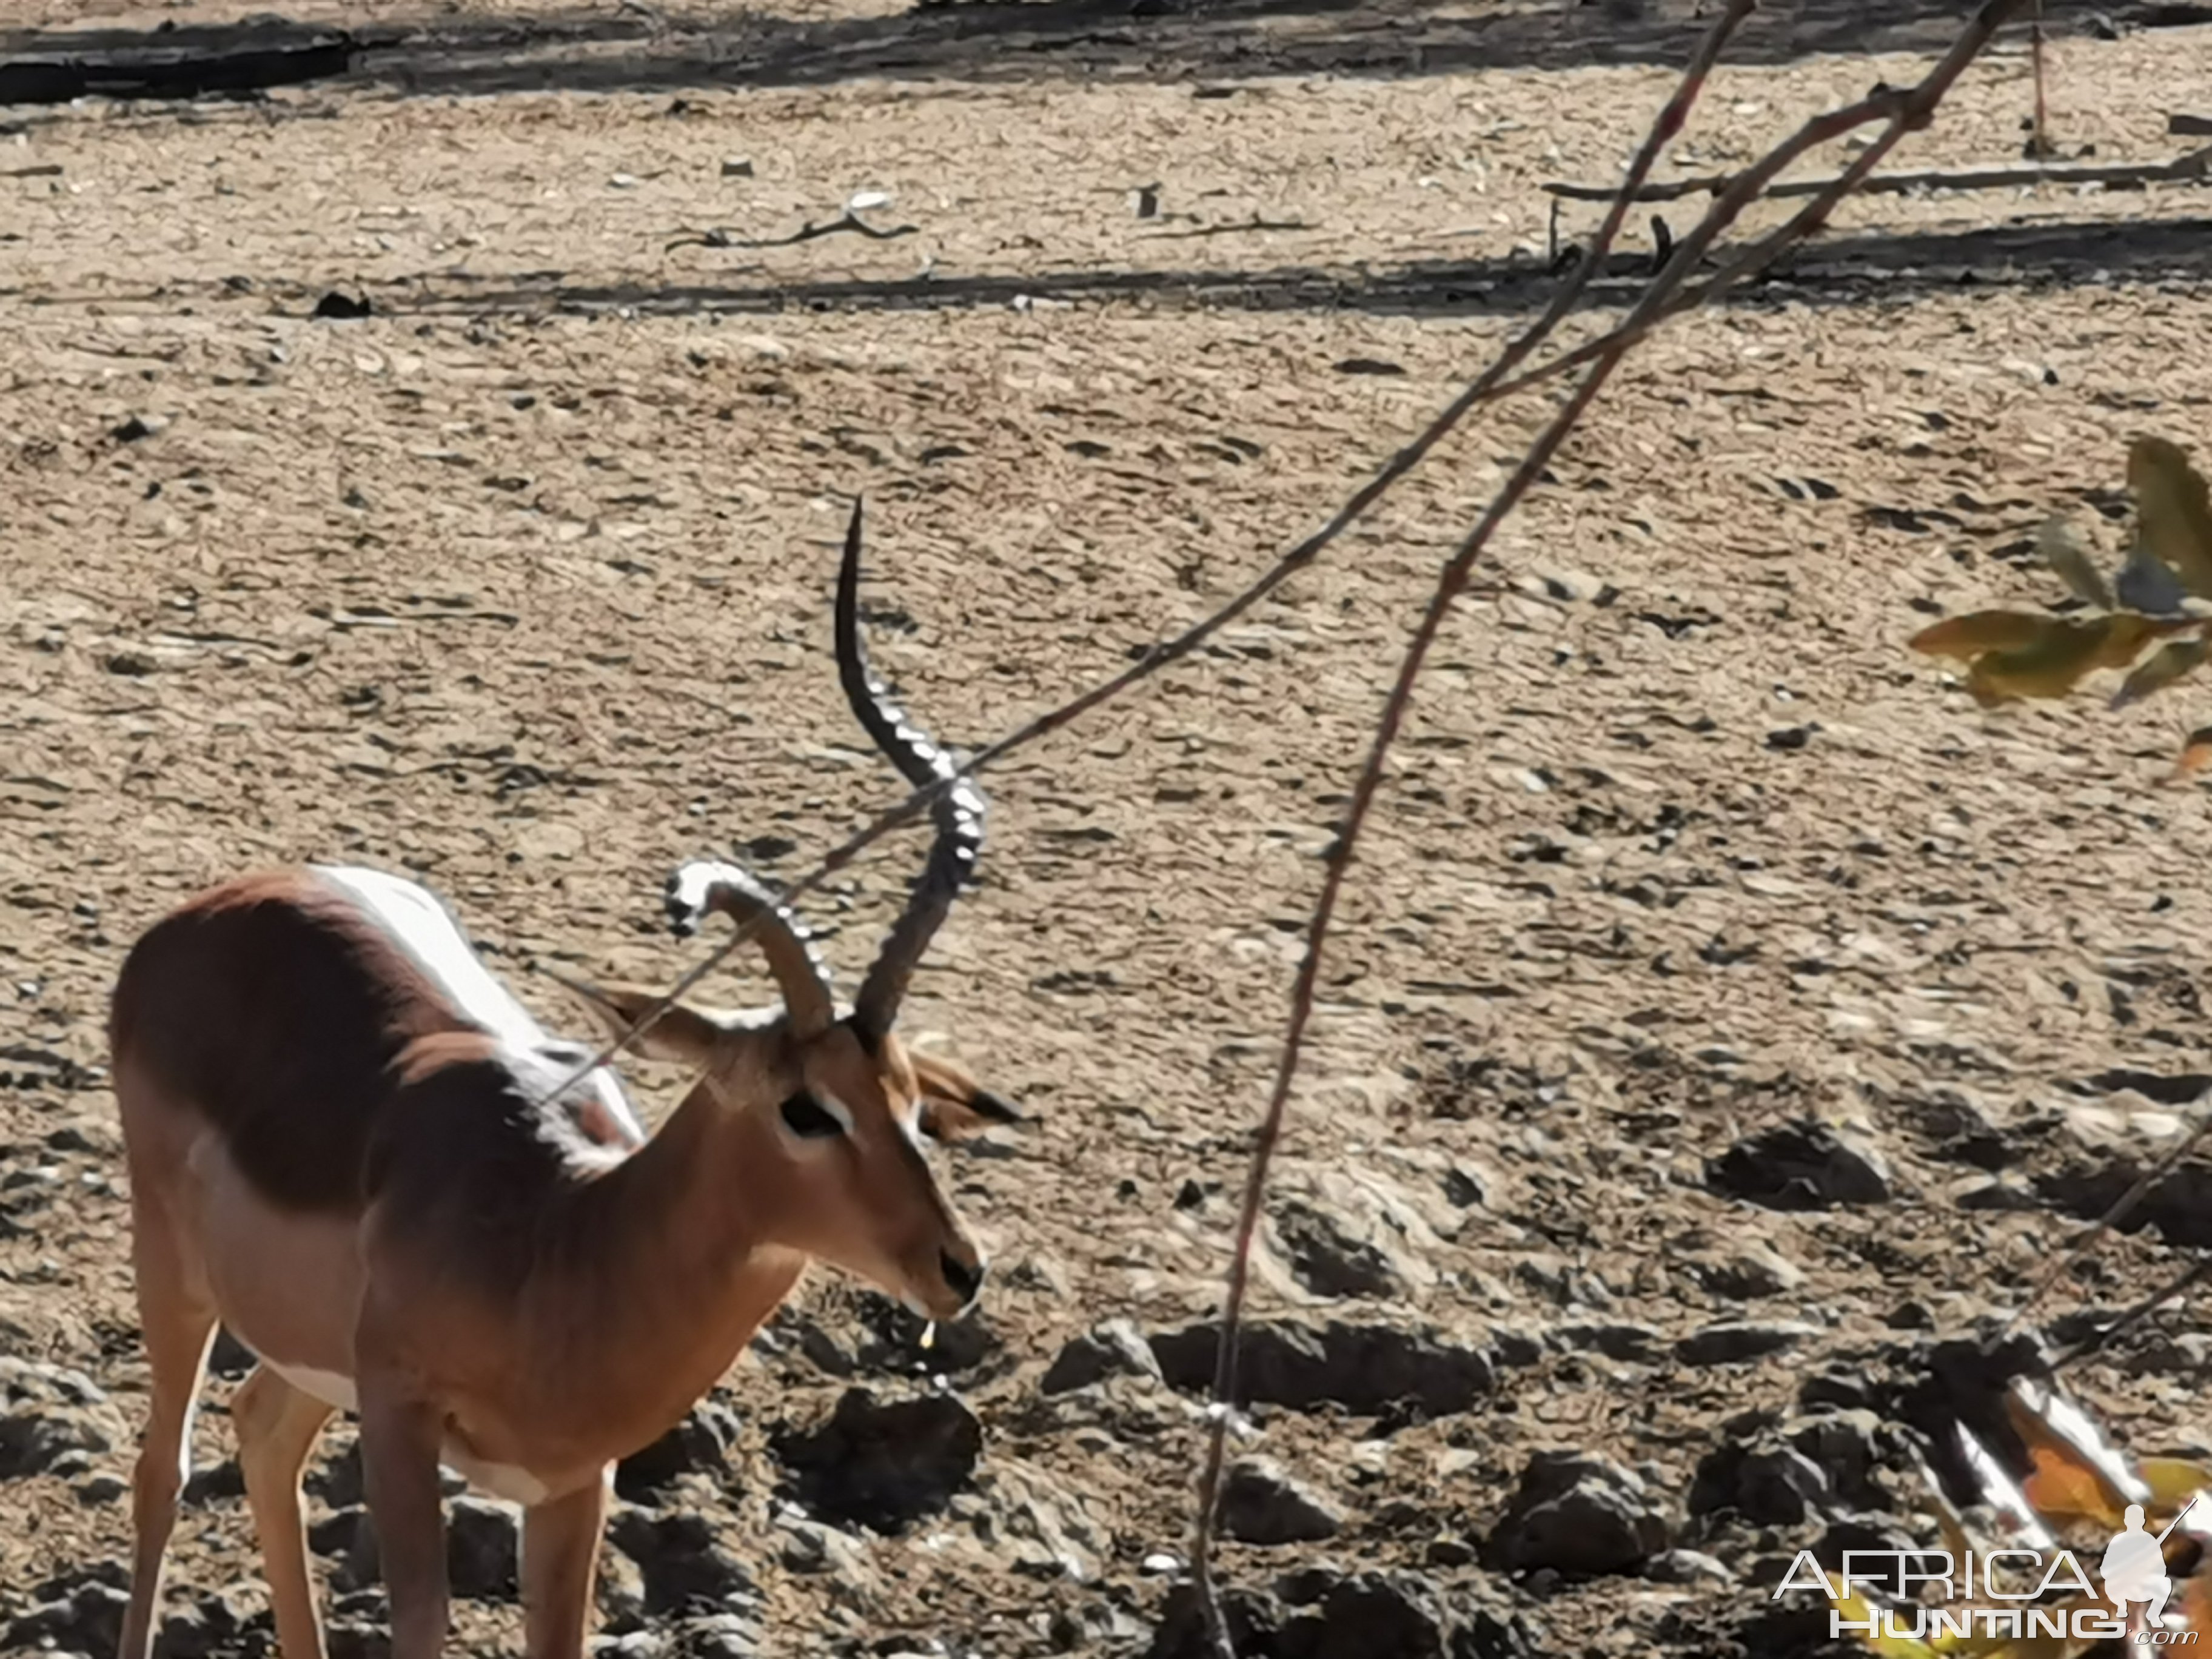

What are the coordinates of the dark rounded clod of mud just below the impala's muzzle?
(774, 1389, 982, 1533)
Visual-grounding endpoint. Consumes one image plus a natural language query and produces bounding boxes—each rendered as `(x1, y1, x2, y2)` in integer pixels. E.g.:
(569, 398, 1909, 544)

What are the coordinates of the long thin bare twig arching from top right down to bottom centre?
(1192, 0, 2022, 1659)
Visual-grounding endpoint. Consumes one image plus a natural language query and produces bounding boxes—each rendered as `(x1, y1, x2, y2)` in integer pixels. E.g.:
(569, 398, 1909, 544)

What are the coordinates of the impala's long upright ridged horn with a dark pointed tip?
(836, 500, 984, 1037)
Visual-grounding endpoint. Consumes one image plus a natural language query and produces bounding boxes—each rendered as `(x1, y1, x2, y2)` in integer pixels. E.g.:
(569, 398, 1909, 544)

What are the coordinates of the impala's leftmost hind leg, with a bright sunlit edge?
(117, 1172, 215, 1659)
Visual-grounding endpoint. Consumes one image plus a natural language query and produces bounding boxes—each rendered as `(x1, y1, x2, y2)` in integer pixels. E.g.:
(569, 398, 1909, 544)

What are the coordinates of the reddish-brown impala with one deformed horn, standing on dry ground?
(109, 506, 1017, 1659)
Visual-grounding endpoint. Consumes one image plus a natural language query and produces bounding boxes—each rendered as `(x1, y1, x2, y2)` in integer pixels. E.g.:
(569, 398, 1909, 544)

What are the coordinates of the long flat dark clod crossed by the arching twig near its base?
(1153, 1321, 1495, 1416)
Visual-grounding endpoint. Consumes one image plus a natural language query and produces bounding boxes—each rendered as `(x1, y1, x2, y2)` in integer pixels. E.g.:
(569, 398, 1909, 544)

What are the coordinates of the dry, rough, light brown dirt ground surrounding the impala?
(0, 0, 2212, 1657)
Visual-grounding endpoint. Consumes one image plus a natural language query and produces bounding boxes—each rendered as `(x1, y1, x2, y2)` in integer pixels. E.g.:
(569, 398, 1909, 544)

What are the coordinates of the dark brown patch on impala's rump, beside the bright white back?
(109, 871, 474, 1210)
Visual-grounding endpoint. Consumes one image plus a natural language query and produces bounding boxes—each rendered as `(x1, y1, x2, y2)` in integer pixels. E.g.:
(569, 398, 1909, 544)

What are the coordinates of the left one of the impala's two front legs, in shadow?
(361, 1373, 447, 1659)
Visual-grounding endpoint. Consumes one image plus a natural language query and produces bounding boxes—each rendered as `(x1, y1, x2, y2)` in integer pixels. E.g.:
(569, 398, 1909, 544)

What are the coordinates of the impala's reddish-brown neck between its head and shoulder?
(544, 1088, 805, 1451)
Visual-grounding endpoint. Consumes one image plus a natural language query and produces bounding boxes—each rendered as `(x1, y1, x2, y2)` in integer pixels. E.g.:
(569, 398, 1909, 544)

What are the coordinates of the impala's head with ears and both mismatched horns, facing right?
(577, 506, 1020, 1318)
